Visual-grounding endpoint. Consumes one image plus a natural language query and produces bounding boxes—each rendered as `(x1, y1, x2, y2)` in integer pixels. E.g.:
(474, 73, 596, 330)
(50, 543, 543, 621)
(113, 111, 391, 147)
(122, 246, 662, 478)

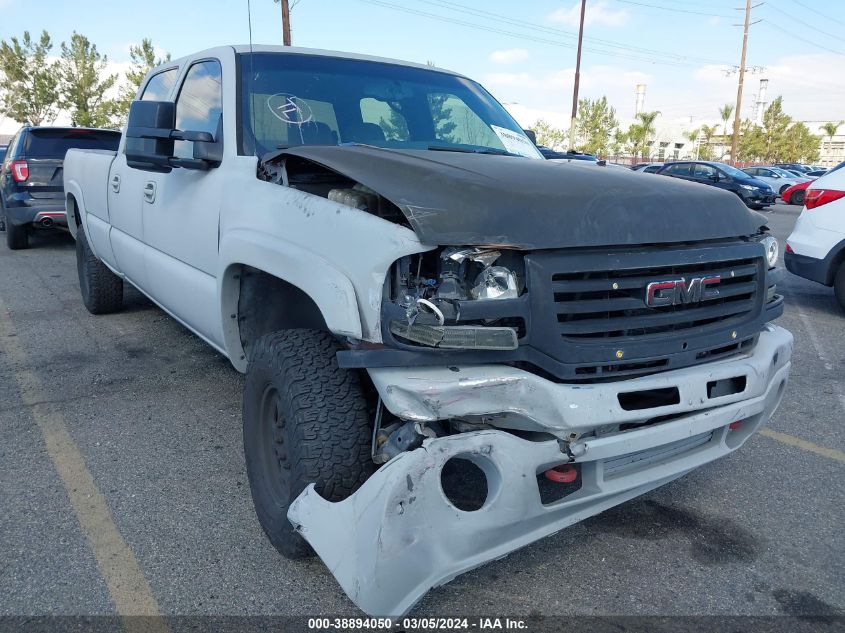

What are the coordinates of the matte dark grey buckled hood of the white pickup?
(275, 146, 762, 250)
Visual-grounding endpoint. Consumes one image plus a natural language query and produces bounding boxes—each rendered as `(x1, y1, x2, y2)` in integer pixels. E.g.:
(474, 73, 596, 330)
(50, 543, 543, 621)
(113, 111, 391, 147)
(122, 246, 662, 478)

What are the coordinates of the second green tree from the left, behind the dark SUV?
(59, 31, 119, 127)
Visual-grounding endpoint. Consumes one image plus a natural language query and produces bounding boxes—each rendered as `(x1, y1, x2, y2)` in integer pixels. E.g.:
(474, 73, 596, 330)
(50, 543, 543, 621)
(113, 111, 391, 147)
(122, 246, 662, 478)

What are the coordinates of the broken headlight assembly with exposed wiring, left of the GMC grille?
(388, 247, 525, 350)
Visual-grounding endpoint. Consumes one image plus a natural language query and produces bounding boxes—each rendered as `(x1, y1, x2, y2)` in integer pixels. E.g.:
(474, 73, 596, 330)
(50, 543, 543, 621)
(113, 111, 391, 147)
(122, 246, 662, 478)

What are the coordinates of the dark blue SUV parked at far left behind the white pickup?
(0, 126, 120, 250)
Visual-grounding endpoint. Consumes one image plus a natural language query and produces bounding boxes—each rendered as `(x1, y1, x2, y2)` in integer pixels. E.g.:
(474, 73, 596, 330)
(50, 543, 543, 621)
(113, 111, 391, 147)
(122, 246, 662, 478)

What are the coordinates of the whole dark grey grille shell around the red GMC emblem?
(526, 242, 767, 378)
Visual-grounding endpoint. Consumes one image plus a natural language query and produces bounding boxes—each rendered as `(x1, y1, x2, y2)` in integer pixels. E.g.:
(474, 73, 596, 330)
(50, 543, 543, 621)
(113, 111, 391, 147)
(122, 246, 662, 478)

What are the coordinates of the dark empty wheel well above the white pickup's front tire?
(238, 266, 328, 358)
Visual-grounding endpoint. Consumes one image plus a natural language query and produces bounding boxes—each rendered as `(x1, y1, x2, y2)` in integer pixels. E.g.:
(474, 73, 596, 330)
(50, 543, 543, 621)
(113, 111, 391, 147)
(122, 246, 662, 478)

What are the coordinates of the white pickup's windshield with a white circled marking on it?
(240, 53, 542, 159)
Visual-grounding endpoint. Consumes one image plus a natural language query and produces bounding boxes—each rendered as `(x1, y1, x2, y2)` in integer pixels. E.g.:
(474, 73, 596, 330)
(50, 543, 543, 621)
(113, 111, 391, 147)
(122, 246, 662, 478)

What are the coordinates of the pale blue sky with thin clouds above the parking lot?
(0, 0, 845, 132)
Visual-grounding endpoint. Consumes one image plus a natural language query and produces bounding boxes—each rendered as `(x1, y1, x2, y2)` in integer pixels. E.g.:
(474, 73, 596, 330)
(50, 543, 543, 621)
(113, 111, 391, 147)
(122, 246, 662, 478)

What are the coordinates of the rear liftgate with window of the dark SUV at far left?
(21, 128, 120, 199)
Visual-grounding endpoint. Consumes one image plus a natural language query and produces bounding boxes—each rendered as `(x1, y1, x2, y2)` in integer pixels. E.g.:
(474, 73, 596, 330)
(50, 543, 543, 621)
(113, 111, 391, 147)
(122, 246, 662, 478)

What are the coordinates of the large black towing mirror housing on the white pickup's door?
(124, 101, 176, 173)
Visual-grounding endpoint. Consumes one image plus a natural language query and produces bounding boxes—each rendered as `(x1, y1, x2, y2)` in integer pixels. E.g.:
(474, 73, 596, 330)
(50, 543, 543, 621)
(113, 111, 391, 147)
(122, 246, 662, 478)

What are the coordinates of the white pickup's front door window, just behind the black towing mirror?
(174, 60, 223, 158)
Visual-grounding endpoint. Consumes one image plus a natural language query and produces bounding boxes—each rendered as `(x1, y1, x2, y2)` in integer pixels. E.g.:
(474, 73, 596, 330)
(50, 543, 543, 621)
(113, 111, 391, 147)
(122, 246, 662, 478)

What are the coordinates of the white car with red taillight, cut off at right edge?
(784, 162, 845, 310)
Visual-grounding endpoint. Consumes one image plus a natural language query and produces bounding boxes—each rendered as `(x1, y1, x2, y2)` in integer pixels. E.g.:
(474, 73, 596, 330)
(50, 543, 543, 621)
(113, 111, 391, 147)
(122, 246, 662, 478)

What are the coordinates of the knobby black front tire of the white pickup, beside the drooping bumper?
(243, 330, 373, 558)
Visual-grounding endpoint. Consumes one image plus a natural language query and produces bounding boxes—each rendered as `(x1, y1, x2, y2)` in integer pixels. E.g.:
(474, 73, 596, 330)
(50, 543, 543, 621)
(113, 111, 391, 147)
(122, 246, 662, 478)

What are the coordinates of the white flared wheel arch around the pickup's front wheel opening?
(217, 229, 362, 371)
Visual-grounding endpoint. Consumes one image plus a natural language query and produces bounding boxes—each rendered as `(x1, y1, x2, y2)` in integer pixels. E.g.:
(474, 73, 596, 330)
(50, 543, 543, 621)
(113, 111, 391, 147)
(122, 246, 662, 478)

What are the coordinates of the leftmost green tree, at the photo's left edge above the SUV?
(0, 31, 59, 125)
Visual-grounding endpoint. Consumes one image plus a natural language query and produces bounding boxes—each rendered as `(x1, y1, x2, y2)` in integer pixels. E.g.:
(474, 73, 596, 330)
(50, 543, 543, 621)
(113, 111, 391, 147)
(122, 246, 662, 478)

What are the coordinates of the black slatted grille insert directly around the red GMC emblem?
(552, 258, 760, 339)
